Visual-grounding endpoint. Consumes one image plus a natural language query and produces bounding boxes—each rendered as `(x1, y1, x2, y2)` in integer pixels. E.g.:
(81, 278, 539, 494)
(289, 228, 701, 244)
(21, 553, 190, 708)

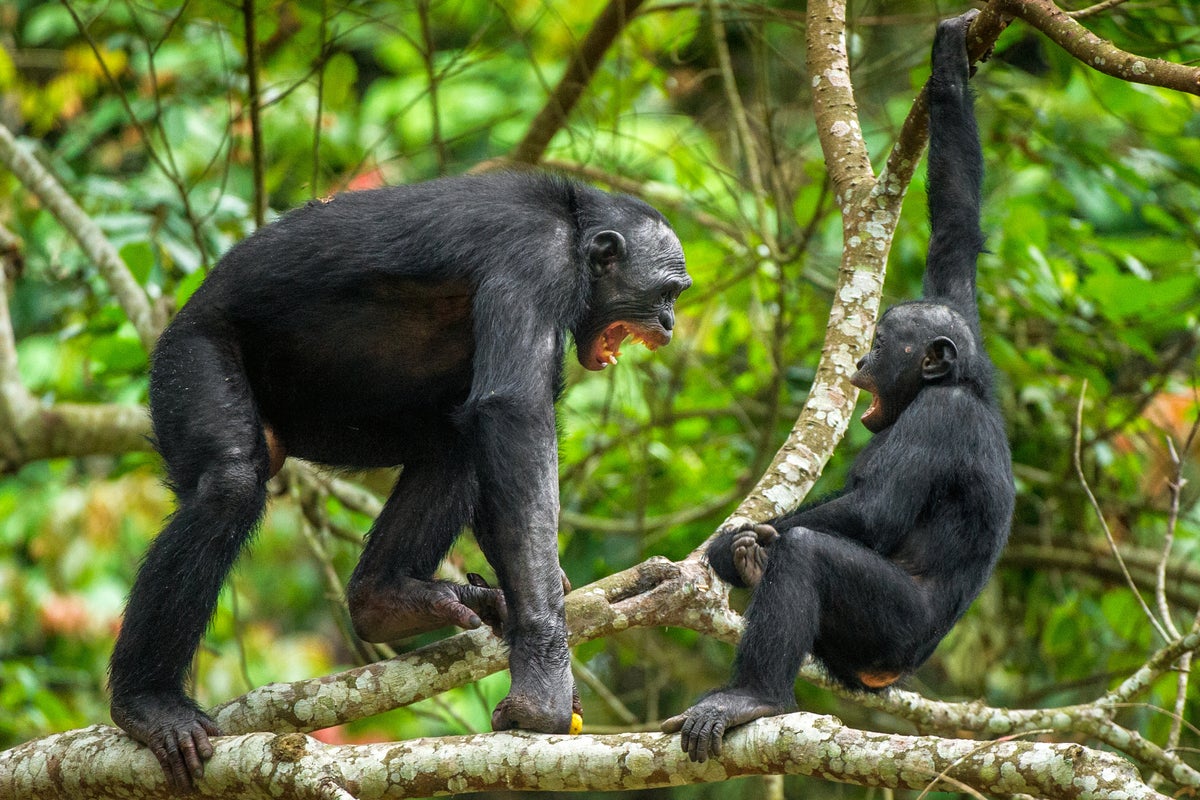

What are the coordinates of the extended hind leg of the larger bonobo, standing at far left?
(109, 327, 270, 792)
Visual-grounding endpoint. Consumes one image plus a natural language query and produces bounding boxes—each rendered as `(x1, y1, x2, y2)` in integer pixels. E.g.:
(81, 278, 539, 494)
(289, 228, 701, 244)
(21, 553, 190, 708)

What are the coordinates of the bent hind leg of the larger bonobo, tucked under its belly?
(347, 450, 505, 642)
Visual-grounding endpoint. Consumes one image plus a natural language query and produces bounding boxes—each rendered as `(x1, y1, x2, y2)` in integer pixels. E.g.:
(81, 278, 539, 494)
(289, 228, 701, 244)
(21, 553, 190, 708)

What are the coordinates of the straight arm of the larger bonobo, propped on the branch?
(461, 287, 574, 733)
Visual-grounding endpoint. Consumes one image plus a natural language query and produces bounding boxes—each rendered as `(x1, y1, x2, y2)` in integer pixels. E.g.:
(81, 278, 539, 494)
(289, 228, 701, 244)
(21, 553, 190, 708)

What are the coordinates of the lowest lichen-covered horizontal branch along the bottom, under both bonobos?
(0, 712, 1165, 800)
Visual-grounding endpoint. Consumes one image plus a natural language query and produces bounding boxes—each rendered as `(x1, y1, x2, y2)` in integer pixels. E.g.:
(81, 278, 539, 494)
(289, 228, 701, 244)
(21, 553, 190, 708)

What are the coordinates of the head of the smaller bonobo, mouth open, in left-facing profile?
(850, 300, 990, 433)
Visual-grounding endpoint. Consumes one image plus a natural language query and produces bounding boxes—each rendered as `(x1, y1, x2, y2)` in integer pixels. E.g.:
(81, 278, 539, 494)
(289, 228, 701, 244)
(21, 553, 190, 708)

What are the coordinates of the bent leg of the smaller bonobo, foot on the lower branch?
(662, 528, 929, 762)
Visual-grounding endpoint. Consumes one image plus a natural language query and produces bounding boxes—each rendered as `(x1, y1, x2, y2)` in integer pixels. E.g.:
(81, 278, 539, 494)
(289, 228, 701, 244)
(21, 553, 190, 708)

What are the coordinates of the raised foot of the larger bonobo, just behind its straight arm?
(348, 576, 508, 642)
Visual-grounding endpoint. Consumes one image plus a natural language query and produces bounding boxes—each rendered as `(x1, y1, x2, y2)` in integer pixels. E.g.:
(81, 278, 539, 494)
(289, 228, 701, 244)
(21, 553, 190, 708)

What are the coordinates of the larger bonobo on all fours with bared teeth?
(110, 173, 691, 790)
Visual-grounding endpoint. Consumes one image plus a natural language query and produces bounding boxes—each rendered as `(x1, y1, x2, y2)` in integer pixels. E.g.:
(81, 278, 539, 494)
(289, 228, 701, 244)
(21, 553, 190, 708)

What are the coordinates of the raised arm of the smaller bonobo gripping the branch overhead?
(924, 11, 984, 328)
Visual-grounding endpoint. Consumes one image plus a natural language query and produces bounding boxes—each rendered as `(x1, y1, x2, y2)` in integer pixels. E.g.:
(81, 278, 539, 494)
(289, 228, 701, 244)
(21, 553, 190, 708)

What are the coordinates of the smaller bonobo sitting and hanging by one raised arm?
(664, 12, 1014, 762)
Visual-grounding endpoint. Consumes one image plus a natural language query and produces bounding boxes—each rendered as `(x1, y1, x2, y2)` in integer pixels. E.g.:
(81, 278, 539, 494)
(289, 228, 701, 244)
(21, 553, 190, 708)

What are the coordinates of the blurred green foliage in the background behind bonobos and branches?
(0, 0, 1200, 796)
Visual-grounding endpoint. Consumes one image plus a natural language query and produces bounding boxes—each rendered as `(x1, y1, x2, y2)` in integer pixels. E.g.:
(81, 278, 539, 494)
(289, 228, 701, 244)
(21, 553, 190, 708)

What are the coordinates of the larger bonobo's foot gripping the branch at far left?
(112, 692, 221, 794)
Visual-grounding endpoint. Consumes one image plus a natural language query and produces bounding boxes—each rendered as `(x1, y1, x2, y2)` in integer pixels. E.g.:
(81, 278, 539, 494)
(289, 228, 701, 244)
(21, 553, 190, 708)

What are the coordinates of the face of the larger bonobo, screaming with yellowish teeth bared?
(574, 216, 691, 369)
